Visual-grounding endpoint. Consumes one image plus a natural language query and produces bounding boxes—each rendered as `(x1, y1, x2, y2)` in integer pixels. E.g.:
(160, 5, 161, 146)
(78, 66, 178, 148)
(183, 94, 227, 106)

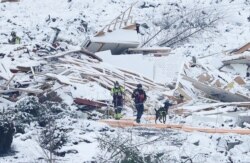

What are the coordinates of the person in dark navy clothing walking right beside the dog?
(132, 84, 147, 123)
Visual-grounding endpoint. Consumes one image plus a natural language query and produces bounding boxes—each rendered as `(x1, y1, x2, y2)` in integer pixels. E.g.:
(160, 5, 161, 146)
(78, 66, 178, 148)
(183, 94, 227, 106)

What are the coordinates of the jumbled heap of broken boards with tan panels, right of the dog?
(179, 59, 250, 102)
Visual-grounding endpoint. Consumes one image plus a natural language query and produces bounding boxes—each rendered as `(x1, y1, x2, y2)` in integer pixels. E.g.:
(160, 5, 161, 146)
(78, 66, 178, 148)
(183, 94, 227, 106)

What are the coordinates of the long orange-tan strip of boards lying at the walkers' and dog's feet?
(99, 119, 250, 135)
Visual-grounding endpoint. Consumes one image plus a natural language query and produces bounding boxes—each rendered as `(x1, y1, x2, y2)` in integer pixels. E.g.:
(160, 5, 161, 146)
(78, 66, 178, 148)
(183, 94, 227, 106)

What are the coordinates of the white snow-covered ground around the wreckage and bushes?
(0, 0, 250, 163)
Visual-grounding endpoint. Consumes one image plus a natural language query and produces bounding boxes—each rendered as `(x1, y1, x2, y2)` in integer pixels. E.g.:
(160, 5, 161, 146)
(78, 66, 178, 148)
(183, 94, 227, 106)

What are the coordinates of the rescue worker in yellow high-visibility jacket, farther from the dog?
(111, 81, 124, 120)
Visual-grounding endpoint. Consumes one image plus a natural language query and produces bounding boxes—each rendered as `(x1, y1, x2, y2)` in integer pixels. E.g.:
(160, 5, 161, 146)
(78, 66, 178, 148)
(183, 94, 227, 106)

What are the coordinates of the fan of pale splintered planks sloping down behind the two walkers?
(45, 51, 166, 93)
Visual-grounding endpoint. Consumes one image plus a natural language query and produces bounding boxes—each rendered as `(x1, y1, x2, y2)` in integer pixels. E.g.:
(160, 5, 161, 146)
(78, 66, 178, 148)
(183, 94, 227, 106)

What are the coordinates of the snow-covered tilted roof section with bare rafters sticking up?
(82, 2, 171, 56)
